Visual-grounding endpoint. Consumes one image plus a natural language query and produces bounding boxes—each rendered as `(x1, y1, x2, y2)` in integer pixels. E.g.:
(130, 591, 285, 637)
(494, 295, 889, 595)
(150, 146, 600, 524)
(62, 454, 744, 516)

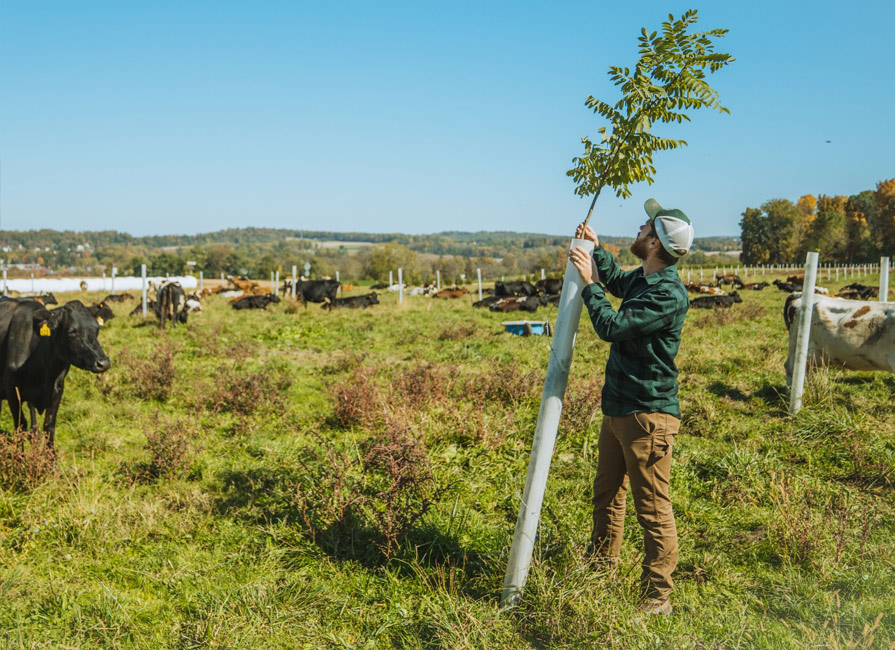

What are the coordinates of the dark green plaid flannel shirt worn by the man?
(581, 247, 690, 418)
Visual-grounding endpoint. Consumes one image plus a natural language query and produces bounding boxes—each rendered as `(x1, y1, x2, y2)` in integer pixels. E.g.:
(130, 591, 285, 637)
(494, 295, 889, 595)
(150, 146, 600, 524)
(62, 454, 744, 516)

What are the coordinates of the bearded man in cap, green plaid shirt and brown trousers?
(569, 199, 693, 614)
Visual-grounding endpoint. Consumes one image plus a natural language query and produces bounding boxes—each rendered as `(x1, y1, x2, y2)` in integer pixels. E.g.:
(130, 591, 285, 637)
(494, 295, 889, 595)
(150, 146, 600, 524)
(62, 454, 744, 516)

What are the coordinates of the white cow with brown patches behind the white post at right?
(783, 292, 895, 386)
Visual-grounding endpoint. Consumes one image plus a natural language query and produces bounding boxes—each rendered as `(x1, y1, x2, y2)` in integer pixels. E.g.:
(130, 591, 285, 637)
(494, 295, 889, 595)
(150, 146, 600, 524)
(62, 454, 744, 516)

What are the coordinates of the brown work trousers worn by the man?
(591, 413, 680, 600)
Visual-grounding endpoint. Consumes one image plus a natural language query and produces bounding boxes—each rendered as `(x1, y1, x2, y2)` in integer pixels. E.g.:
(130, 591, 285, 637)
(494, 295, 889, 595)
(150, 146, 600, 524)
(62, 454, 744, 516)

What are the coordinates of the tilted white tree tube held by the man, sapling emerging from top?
(500, 239, 593, 607)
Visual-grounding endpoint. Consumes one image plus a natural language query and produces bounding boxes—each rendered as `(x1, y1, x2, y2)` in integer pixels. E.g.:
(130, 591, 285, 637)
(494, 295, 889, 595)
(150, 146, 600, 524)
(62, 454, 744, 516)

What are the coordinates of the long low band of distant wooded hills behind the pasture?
(0, 228, 738, 282)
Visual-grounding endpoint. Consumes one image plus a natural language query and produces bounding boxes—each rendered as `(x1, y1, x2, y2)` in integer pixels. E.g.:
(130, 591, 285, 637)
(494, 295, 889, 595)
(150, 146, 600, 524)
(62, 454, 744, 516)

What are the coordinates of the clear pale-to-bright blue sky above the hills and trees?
(0, 0, 895, 236)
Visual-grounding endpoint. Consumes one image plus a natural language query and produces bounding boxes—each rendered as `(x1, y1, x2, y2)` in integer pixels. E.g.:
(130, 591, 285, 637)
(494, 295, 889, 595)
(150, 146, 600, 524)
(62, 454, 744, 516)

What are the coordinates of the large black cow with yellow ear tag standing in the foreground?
(0, 299, 111, 450)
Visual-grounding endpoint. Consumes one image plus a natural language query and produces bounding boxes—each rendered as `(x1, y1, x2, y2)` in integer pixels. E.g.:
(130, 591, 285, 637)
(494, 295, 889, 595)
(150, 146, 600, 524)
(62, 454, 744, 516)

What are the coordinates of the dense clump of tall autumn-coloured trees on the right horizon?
(740, 179, 895, 264)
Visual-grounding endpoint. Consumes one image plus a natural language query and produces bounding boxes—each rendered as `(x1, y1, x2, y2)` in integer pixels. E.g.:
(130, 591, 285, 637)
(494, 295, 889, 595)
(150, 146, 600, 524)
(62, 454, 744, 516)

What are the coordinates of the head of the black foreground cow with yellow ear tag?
(42, 300, 112, 373)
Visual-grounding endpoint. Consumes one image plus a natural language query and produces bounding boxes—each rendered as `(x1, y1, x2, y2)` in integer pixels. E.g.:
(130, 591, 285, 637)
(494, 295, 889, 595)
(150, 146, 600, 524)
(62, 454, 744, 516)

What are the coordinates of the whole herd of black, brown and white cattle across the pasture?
(0, 268, 895, 449)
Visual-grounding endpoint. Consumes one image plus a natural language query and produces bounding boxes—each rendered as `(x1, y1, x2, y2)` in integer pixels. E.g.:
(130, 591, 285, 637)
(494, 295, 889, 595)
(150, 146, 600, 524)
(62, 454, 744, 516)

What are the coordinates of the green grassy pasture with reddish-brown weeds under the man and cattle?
(0, 276, 895, 650)
